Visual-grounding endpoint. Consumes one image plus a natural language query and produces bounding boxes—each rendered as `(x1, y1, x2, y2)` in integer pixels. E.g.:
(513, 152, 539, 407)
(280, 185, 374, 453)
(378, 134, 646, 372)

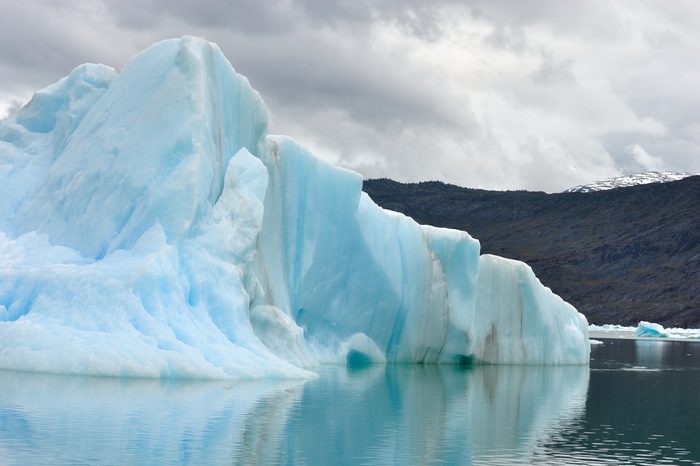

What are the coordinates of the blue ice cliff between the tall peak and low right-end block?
(254, 137, 479, 362)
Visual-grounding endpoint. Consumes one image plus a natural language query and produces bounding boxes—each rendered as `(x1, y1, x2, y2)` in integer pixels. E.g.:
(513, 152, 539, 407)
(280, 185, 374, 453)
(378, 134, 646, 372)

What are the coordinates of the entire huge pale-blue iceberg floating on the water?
(0, 37, 590, 378)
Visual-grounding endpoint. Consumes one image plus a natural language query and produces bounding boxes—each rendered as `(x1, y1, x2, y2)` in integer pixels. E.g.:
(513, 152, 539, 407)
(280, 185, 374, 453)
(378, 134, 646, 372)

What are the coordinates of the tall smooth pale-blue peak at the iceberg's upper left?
(16, 37, 268, 257)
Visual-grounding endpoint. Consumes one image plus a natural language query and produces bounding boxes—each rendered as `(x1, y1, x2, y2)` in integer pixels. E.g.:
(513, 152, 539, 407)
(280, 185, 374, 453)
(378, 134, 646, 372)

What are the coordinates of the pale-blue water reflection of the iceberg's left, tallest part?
(0, 371, 303, 466)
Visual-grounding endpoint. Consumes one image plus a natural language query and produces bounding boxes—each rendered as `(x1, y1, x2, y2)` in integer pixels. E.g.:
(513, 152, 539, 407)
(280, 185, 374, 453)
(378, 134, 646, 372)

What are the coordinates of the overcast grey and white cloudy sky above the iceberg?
(0, 0, 700, 192)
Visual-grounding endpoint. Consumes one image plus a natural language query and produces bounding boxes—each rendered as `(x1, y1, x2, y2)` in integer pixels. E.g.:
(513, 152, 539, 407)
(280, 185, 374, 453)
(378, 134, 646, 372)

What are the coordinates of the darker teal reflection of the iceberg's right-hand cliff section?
(288, 365, 589, 464)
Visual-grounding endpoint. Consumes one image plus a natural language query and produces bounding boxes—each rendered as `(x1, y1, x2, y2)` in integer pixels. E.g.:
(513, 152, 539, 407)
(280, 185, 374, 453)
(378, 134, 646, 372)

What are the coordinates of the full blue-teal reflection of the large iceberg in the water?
(0, 365, 589, 465)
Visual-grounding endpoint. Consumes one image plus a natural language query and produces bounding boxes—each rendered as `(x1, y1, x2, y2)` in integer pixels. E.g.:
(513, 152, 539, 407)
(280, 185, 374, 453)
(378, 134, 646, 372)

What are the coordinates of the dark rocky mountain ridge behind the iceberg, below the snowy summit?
(364, 176, 700, 328)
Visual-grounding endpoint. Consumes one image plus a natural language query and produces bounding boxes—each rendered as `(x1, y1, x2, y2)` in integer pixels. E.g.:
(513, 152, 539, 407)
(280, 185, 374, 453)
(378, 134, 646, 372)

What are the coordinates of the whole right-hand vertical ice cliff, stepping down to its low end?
(254, 137, 588, 364)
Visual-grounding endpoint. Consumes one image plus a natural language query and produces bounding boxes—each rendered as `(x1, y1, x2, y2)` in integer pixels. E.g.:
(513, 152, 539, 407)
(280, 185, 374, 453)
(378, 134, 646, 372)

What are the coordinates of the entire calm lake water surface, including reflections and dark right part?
(0, 340, 700, 466)
